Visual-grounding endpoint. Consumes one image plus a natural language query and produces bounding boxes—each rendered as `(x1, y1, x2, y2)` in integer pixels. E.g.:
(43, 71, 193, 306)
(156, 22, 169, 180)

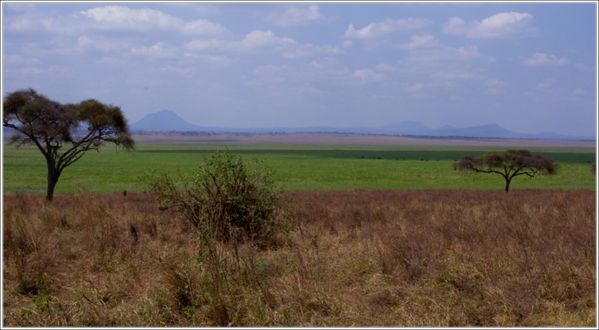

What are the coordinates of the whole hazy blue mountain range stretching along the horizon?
(131, 110, 594, 140)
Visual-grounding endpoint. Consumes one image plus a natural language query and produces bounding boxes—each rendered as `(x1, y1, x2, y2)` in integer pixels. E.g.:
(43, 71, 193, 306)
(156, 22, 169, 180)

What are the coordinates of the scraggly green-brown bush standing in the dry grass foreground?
(150, 153, 283, 245)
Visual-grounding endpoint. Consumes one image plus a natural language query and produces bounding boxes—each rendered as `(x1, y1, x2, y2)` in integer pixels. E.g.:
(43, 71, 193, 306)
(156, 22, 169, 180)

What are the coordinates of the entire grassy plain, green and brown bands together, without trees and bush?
(3, 133, 596, 326)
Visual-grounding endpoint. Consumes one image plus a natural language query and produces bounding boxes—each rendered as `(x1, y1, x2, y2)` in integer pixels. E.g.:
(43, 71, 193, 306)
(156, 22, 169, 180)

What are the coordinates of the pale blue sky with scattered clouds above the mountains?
(2, 2, 597, 136)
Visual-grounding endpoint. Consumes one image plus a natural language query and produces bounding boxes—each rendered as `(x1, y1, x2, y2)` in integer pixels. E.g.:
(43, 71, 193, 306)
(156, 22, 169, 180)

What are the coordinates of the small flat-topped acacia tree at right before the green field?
(455, 150, 557, 192)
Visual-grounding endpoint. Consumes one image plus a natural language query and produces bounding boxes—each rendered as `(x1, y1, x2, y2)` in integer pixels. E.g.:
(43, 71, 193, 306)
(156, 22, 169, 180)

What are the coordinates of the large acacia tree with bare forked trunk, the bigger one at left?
(3, 89, 134, 201)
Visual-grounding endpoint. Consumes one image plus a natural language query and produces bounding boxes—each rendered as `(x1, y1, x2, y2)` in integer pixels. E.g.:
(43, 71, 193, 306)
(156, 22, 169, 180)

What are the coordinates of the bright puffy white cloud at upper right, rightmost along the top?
(443, 12, 535, 39)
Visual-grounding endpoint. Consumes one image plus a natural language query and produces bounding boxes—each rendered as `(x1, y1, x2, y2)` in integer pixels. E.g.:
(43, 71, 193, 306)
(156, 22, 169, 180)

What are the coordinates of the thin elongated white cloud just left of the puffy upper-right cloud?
(345, 18, 430, 39)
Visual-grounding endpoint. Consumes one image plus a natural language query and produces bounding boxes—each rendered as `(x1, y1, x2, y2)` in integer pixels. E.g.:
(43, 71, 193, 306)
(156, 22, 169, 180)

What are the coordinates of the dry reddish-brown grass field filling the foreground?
(3, 190, 597, 327)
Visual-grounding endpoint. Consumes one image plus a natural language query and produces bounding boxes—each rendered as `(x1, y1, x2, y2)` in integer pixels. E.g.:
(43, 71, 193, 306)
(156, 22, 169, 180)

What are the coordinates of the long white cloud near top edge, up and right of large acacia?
(80, 6, 226, 35)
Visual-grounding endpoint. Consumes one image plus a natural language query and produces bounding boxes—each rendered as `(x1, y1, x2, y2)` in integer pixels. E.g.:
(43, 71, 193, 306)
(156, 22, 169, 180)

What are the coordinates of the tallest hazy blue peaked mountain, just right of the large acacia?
(131, 110, 204, 132)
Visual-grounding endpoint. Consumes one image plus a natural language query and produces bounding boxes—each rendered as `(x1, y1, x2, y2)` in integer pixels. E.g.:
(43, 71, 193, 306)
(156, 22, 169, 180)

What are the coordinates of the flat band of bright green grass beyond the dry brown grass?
(3, 144, 595, 194)
